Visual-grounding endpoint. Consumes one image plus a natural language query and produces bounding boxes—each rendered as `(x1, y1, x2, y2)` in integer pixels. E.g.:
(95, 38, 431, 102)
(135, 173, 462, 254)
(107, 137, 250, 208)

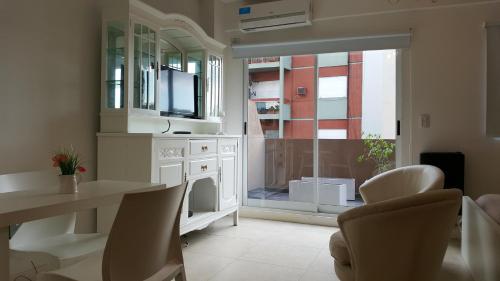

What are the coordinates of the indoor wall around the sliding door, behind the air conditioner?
(220, 0, 500, 197)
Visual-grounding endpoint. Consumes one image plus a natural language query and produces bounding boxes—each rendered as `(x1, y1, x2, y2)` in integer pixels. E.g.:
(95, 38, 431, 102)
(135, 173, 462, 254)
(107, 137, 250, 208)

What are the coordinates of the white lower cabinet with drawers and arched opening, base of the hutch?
(97, 133, 241, 234)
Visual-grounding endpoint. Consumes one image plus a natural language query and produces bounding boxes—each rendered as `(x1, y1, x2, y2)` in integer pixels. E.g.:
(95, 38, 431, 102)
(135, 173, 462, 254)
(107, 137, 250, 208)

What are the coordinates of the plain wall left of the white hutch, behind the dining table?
(0, 0, 101, 230)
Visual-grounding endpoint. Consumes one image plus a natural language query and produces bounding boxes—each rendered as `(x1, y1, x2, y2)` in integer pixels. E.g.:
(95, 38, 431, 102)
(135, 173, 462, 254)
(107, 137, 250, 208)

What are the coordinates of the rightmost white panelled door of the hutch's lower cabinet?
(219, 140, 238, 210)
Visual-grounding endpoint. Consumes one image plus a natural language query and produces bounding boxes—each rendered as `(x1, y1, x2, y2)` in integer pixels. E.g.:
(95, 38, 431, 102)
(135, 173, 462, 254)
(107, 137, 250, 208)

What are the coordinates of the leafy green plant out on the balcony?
(358, 134, 396, 174)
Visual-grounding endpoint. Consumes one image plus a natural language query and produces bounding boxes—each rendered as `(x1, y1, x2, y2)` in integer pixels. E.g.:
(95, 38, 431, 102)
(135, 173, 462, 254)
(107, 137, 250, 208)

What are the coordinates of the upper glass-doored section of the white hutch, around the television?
(101, 0, 225, 133)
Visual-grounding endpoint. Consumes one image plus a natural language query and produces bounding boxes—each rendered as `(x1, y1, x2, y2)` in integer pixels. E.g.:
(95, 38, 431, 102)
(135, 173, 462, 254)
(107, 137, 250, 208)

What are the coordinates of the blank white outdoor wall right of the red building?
(361, 50, 396, 139)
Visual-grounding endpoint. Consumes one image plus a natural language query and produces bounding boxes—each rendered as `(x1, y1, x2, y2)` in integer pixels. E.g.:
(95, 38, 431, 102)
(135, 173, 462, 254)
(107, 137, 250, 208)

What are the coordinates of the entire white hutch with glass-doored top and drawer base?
(97, 0, 241, 233)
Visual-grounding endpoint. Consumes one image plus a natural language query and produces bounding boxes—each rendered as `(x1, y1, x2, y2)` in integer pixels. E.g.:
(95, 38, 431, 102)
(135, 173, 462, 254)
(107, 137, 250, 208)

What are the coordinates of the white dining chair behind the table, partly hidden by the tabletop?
(4, 170, 107, 279)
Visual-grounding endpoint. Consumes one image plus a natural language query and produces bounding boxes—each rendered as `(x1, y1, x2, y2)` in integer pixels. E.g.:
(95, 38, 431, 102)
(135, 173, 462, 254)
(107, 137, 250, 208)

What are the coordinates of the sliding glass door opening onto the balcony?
(244, 50, 396, 213)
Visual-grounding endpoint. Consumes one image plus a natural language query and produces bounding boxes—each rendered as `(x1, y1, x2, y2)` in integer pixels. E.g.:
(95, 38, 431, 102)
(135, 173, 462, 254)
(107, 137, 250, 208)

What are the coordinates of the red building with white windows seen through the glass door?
(249, 52, 363, 139)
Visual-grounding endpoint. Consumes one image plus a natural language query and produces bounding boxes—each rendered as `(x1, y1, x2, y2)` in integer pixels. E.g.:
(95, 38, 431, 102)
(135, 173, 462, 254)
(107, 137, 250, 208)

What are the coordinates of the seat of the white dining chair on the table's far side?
(11, 233, 107, 268)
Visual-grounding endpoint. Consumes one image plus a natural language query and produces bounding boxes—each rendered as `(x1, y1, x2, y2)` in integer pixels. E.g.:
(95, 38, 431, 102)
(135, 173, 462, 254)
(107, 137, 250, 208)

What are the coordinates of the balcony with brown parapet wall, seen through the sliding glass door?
(248, 136, 394, 207)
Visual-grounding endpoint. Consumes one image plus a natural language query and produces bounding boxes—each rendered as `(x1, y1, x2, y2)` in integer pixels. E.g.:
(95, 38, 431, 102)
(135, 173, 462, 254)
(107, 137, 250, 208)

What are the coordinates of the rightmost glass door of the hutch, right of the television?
(206, 55, 222, 117)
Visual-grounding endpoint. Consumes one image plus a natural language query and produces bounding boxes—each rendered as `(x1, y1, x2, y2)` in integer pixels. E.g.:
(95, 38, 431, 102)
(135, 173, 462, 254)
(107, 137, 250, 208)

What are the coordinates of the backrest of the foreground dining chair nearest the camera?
(102, 183, 186, 281)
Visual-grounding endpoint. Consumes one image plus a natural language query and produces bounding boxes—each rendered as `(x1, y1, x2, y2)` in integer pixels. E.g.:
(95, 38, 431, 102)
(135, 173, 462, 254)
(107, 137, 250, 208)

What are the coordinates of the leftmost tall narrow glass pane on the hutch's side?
(105, 22, 125, 108)
